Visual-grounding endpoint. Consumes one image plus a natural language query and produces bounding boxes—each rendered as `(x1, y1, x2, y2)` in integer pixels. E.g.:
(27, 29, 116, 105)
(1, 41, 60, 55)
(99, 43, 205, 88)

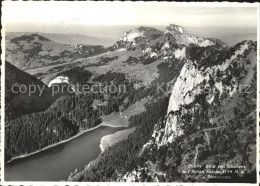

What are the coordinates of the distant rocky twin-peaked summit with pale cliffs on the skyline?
(114, 24, 227, 63)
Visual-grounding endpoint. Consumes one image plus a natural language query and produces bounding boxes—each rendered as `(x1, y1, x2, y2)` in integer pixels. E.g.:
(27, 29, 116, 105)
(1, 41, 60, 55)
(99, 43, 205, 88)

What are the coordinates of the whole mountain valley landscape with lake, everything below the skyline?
(5, 24, 256, 182)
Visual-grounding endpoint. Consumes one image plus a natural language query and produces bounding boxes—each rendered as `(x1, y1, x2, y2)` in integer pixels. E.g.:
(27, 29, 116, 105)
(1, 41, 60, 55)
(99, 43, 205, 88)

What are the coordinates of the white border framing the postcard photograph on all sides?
(1, 1, 260, 186)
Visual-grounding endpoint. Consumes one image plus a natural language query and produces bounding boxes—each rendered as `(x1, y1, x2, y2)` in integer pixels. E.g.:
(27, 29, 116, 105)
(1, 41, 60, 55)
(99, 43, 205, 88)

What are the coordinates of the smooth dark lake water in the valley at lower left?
(5, 127, 122, 181)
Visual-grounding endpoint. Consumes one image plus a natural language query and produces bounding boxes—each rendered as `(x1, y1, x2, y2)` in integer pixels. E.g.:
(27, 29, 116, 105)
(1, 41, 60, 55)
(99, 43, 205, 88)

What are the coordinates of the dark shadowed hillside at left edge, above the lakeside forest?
(5, 61, 57, 121)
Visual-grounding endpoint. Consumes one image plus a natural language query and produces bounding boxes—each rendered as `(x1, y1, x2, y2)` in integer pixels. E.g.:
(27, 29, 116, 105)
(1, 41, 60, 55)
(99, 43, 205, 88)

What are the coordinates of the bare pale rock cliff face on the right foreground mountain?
(162, 42, 254, 144)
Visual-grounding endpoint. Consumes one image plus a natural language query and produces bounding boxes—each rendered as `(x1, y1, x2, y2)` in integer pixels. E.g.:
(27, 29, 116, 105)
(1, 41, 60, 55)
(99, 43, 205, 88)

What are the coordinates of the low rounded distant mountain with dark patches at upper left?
(6, 34, 105, 69)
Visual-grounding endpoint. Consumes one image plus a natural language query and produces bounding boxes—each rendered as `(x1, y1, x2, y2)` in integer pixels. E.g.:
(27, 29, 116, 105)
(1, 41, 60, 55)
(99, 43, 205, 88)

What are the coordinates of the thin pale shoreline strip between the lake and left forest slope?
(6, 123, 122, 165)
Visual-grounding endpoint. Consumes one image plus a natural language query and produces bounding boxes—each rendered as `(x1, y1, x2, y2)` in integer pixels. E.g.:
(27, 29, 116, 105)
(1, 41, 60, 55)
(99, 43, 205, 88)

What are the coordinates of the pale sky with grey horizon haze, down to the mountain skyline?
(2, 1, 257, 45)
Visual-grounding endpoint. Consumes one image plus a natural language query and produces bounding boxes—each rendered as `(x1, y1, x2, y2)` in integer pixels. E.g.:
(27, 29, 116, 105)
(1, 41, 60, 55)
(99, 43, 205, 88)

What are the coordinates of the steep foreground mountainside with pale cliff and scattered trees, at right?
(119, 40, 256, 181)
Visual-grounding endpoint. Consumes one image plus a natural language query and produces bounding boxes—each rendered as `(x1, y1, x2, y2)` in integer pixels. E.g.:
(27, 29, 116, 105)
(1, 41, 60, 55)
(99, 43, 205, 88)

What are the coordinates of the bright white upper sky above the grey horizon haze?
(2, 1, 257, 27)
